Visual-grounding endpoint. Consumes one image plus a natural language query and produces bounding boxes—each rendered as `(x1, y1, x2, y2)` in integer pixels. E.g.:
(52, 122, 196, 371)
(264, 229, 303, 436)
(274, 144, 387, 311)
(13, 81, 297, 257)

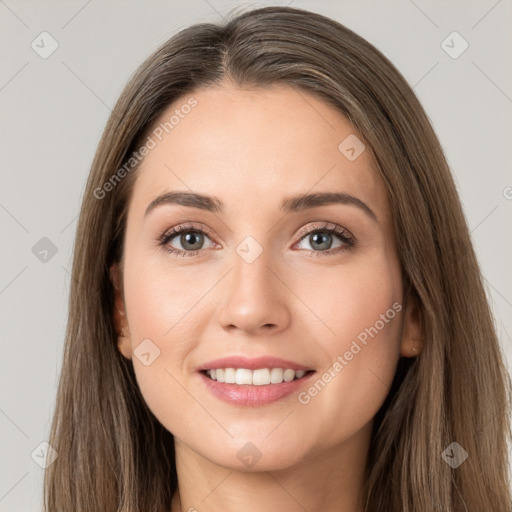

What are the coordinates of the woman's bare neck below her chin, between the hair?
(171, 424, 371, 512)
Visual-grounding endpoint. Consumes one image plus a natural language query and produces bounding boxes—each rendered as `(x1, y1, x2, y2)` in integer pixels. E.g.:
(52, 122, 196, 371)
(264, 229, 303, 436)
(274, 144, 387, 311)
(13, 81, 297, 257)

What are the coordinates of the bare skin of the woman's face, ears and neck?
(111, 81, 422, 512)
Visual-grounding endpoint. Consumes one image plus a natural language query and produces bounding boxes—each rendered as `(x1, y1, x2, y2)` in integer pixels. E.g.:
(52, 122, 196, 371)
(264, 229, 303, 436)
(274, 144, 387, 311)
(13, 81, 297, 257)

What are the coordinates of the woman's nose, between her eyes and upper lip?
(218, 244, 293, 335)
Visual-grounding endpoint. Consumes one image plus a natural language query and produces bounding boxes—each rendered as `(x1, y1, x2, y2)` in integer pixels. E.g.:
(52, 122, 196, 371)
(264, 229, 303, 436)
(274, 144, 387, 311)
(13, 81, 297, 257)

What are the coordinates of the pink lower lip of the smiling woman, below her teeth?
(199, 372, 315, 407)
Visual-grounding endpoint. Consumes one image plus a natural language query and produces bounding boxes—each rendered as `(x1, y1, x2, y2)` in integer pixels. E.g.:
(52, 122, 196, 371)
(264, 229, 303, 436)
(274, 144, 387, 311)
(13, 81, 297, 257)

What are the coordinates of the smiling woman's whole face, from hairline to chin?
(114, 82, 418, 470)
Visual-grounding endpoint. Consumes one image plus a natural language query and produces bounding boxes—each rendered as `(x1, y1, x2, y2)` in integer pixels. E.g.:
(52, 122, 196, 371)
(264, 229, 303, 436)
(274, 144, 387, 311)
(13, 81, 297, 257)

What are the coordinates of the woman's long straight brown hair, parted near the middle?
(44, 7, 512, 512)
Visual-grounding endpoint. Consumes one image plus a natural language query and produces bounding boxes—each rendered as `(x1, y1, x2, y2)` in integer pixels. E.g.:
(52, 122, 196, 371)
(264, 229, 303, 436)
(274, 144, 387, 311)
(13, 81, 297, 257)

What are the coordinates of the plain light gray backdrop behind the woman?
(0, 0, 512, 512)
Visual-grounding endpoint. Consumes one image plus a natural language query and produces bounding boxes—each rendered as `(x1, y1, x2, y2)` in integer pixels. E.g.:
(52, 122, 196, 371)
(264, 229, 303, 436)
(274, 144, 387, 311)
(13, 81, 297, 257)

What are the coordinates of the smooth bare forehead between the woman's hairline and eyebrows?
(127, 82, 387, 221)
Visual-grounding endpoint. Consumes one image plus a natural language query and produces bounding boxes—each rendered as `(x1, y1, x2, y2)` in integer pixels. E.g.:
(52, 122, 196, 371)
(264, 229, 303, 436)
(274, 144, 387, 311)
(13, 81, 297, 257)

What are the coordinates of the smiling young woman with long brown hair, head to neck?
(45, 7, 511, 512)
